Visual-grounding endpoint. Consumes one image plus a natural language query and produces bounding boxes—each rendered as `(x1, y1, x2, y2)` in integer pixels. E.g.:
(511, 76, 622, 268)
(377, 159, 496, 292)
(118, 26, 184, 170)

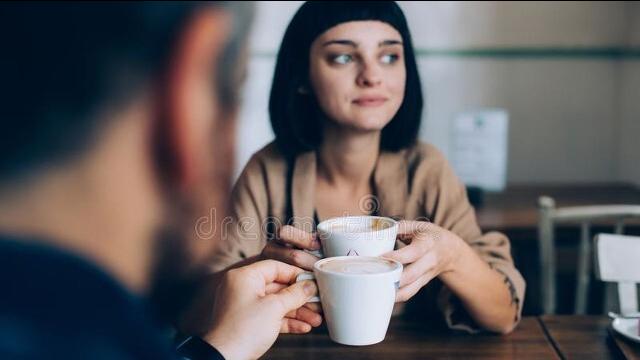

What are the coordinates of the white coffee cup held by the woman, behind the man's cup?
(318, 216, 398, 257)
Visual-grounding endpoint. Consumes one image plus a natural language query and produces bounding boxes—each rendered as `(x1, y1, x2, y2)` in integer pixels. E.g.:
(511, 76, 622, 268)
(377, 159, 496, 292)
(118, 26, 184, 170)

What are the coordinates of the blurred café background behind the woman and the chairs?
(236, 1, 640, 314)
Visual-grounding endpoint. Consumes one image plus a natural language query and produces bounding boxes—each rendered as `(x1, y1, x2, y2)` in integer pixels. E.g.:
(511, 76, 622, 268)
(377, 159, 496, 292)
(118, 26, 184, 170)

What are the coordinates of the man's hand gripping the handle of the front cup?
(203, 260, 322, 359)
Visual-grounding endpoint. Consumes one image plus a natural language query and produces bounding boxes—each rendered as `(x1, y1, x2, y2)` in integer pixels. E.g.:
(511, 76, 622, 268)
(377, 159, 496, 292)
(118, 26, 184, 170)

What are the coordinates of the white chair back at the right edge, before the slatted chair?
(594, 234, 640, 314)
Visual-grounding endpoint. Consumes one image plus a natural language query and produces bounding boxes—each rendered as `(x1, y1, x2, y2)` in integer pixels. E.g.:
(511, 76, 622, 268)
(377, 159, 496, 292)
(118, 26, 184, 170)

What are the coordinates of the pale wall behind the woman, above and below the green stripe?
(238, 1, 640, 183)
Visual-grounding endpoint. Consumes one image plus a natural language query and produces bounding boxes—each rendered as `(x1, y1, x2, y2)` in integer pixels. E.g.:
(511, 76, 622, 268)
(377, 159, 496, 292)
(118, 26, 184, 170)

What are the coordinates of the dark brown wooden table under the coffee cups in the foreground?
(264, 316, 640, 360)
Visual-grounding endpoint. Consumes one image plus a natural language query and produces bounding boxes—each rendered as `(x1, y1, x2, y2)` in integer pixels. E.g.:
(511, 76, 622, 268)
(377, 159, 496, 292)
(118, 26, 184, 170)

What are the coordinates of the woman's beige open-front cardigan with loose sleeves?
(213, 143, 525, 331)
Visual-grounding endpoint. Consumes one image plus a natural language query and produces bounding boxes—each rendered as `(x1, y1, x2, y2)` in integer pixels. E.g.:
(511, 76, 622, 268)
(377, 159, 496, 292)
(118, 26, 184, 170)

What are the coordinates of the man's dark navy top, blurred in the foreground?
(0, 235, 223, 360)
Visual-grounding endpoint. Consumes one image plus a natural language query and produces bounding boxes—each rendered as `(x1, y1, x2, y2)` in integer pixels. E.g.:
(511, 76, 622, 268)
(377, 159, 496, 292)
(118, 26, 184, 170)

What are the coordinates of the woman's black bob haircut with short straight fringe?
(269, 1, 422, 159)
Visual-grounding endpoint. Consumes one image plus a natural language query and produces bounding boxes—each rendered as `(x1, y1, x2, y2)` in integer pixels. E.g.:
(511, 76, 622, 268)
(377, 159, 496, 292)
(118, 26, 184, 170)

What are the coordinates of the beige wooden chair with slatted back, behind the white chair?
(538, 196, 640, 314)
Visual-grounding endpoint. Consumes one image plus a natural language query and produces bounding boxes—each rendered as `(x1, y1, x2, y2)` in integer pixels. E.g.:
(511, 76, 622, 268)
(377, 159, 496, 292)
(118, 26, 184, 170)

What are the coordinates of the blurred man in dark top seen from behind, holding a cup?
(0, 2, 317, 359)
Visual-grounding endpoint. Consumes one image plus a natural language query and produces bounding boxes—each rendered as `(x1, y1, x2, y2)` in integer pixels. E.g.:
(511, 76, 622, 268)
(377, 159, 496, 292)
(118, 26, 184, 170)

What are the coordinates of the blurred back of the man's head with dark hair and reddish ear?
(0, 2, 251, 320)
